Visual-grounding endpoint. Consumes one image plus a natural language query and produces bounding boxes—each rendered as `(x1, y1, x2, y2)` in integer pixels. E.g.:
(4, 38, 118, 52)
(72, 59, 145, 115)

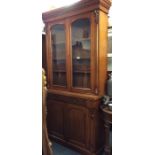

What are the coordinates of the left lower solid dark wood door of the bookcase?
(47, 100, 64, 139)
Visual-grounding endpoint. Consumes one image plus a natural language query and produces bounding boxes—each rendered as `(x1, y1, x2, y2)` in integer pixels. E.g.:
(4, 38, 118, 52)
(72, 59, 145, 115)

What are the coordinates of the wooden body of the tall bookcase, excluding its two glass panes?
(42, 0, 111, 155)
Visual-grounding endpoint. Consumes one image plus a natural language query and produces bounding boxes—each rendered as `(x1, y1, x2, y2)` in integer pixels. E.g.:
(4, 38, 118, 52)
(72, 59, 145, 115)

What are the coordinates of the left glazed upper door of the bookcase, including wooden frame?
(47, 21, 68, 90)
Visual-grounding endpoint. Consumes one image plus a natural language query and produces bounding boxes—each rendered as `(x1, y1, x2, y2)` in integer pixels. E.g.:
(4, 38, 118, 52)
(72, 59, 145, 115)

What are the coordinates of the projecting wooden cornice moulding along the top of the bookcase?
(42, 0, 111, 23)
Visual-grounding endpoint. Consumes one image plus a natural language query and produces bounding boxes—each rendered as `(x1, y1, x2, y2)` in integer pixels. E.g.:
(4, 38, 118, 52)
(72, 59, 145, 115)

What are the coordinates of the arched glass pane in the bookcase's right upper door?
(72, 19, 91, 88)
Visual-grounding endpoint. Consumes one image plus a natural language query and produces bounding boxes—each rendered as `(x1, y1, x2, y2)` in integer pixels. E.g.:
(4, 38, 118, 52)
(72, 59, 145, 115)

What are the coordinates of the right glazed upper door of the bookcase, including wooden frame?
(70, 15, 94, 92)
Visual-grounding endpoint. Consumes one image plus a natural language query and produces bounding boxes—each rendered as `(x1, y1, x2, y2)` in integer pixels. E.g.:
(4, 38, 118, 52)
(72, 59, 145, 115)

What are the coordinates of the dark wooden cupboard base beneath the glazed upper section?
(47, 94, 104, 155)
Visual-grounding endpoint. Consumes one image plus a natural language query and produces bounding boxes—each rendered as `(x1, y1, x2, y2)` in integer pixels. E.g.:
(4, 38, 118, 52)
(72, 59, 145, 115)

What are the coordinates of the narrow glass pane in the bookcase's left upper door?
(51, 25, 66, 86)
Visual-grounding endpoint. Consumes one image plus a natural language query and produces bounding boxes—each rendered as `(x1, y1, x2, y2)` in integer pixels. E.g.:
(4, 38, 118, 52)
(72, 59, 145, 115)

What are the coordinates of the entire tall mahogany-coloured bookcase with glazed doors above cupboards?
(42, 0, 111, 155)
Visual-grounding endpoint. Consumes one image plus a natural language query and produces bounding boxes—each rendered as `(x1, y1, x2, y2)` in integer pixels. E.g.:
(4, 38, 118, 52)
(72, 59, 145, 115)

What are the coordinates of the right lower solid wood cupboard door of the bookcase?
(64, 104, 89, 148)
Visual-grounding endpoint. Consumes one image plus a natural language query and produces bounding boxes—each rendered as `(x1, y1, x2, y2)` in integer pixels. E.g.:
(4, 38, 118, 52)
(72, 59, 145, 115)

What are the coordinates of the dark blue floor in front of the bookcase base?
(52, 142, 104, 155)
